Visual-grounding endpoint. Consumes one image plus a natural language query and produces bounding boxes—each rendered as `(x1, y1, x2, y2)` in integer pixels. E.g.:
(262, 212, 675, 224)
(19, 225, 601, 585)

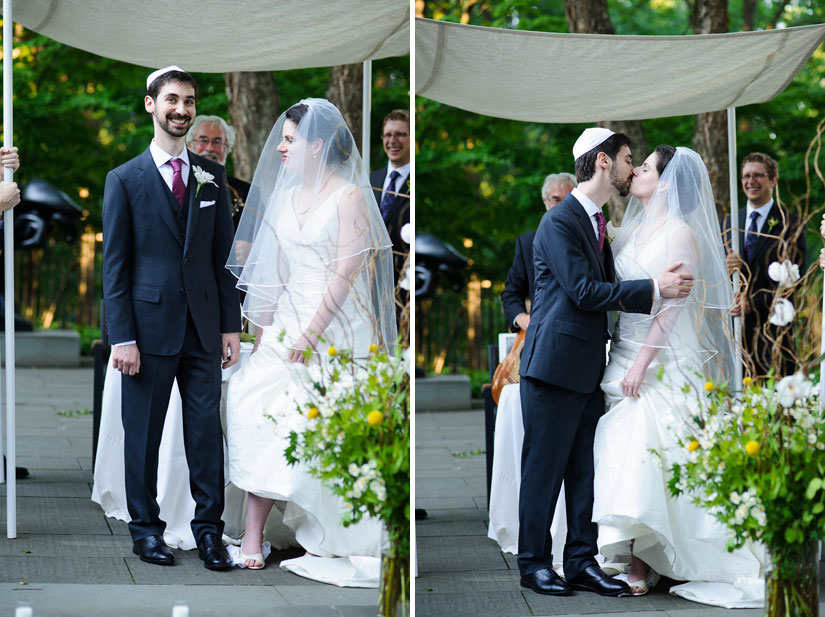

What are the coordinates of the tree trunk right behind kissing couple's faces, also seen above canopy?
(564, 0, 650, 223)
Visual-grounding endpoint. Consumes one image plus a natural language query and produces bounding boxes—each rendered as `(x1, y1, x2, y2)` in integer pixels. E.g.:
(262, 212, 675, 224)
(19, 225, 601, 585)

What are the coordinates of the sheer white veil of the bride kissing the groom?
(613, 147, 736, 381)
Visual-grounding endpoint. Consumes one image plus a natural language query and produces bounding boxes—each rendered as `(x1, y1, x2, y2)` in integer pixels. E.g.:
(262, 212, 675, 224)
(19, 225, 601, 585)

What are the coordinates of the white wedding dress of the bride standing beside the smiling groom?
(227, 186, 382, 587)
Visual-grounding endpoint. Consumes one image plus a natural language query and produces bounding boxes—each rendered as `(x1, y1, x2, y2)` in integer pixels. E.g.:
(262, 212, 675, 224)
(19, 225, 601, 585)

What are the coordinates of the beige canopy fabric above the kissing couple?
(415, 18, 825, 123)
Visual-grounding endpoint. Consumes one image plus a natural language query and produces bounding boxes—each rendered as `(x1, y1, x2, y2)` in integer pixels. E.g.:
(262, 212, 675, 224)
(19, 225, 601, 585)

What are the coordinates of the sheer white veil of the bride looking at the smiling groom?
(226, 98, 396, 348)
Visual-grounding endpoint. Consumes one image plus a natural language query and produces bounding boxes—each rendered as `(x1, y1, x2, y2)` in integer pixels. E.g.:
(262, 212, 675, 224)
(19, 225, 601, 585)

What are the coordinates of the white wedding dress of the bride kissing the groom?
(593, 224, 766, 608)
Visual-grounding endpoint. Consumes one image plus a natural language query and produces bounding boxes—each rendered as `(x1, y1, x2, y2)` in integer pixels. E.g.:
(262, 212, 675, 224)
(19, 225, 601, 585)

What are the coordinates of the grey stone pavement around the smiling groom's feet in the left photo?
(0, 368, 378, 617)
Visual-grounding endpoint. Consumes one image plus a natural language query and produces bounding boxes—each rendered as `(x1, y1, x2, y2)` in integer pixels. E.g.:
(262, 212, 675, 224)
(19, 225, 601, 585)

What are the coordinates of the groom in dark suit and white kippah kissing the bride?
(518, 128, 692, 596)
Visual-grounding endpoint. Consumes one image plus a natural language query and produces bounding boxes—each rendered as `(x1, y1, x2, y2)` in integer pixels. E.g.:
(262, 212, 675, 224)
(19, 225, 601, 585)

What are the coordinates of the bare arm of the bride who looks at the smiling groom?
(290, 188, 372, 362)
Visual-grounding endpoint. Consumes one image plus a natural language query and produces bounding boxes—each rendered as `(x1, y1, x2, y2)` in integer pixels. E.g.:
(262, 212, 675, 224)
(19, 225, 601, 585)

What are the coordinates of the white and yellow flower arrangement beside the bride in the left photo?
(286, 344, 410, 617)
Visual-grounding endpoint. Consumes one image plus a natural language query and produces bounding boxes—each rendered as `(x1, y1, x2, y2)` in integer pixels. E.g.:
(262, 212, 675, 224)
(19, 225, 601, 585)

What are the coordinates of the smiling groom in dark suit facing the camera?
(103, 67, 241, 570)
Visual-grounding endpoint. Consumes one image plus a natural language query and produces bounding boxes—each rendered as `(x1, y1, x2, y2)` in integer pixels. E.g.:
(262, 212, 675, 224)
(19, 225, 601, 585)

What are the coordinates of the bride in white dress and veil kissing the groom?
(593, 146, 765, 607)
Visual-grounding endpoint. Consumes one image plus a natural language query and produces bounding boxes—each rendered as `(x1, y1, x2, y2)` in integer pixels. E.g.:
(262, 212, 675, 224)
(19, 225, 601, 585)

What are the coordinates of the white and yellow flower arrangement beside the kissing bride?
(668, 373, 825, 617)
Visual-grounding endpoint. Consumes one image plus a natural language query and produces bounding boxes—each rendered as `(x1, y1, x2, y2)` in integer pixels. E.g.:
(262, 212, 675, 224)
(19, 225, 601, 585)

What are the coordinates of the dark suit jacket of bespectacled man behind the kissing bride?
(722, 202, 806, 376)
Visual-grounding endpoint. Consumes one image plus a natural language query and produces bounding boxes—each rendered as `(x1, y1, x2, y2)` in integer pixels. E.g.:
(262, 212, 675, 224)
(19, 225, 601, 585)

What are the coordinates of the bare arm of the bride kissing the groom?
(622, 227, 698, 397)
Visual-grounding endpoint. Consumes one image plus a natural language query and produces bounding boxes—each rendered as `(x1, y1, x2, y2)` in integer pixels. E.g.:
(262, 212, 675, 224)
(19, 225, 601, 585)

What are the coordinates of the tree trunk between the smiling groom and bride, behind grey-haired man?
(224, 71, 279, 181)
